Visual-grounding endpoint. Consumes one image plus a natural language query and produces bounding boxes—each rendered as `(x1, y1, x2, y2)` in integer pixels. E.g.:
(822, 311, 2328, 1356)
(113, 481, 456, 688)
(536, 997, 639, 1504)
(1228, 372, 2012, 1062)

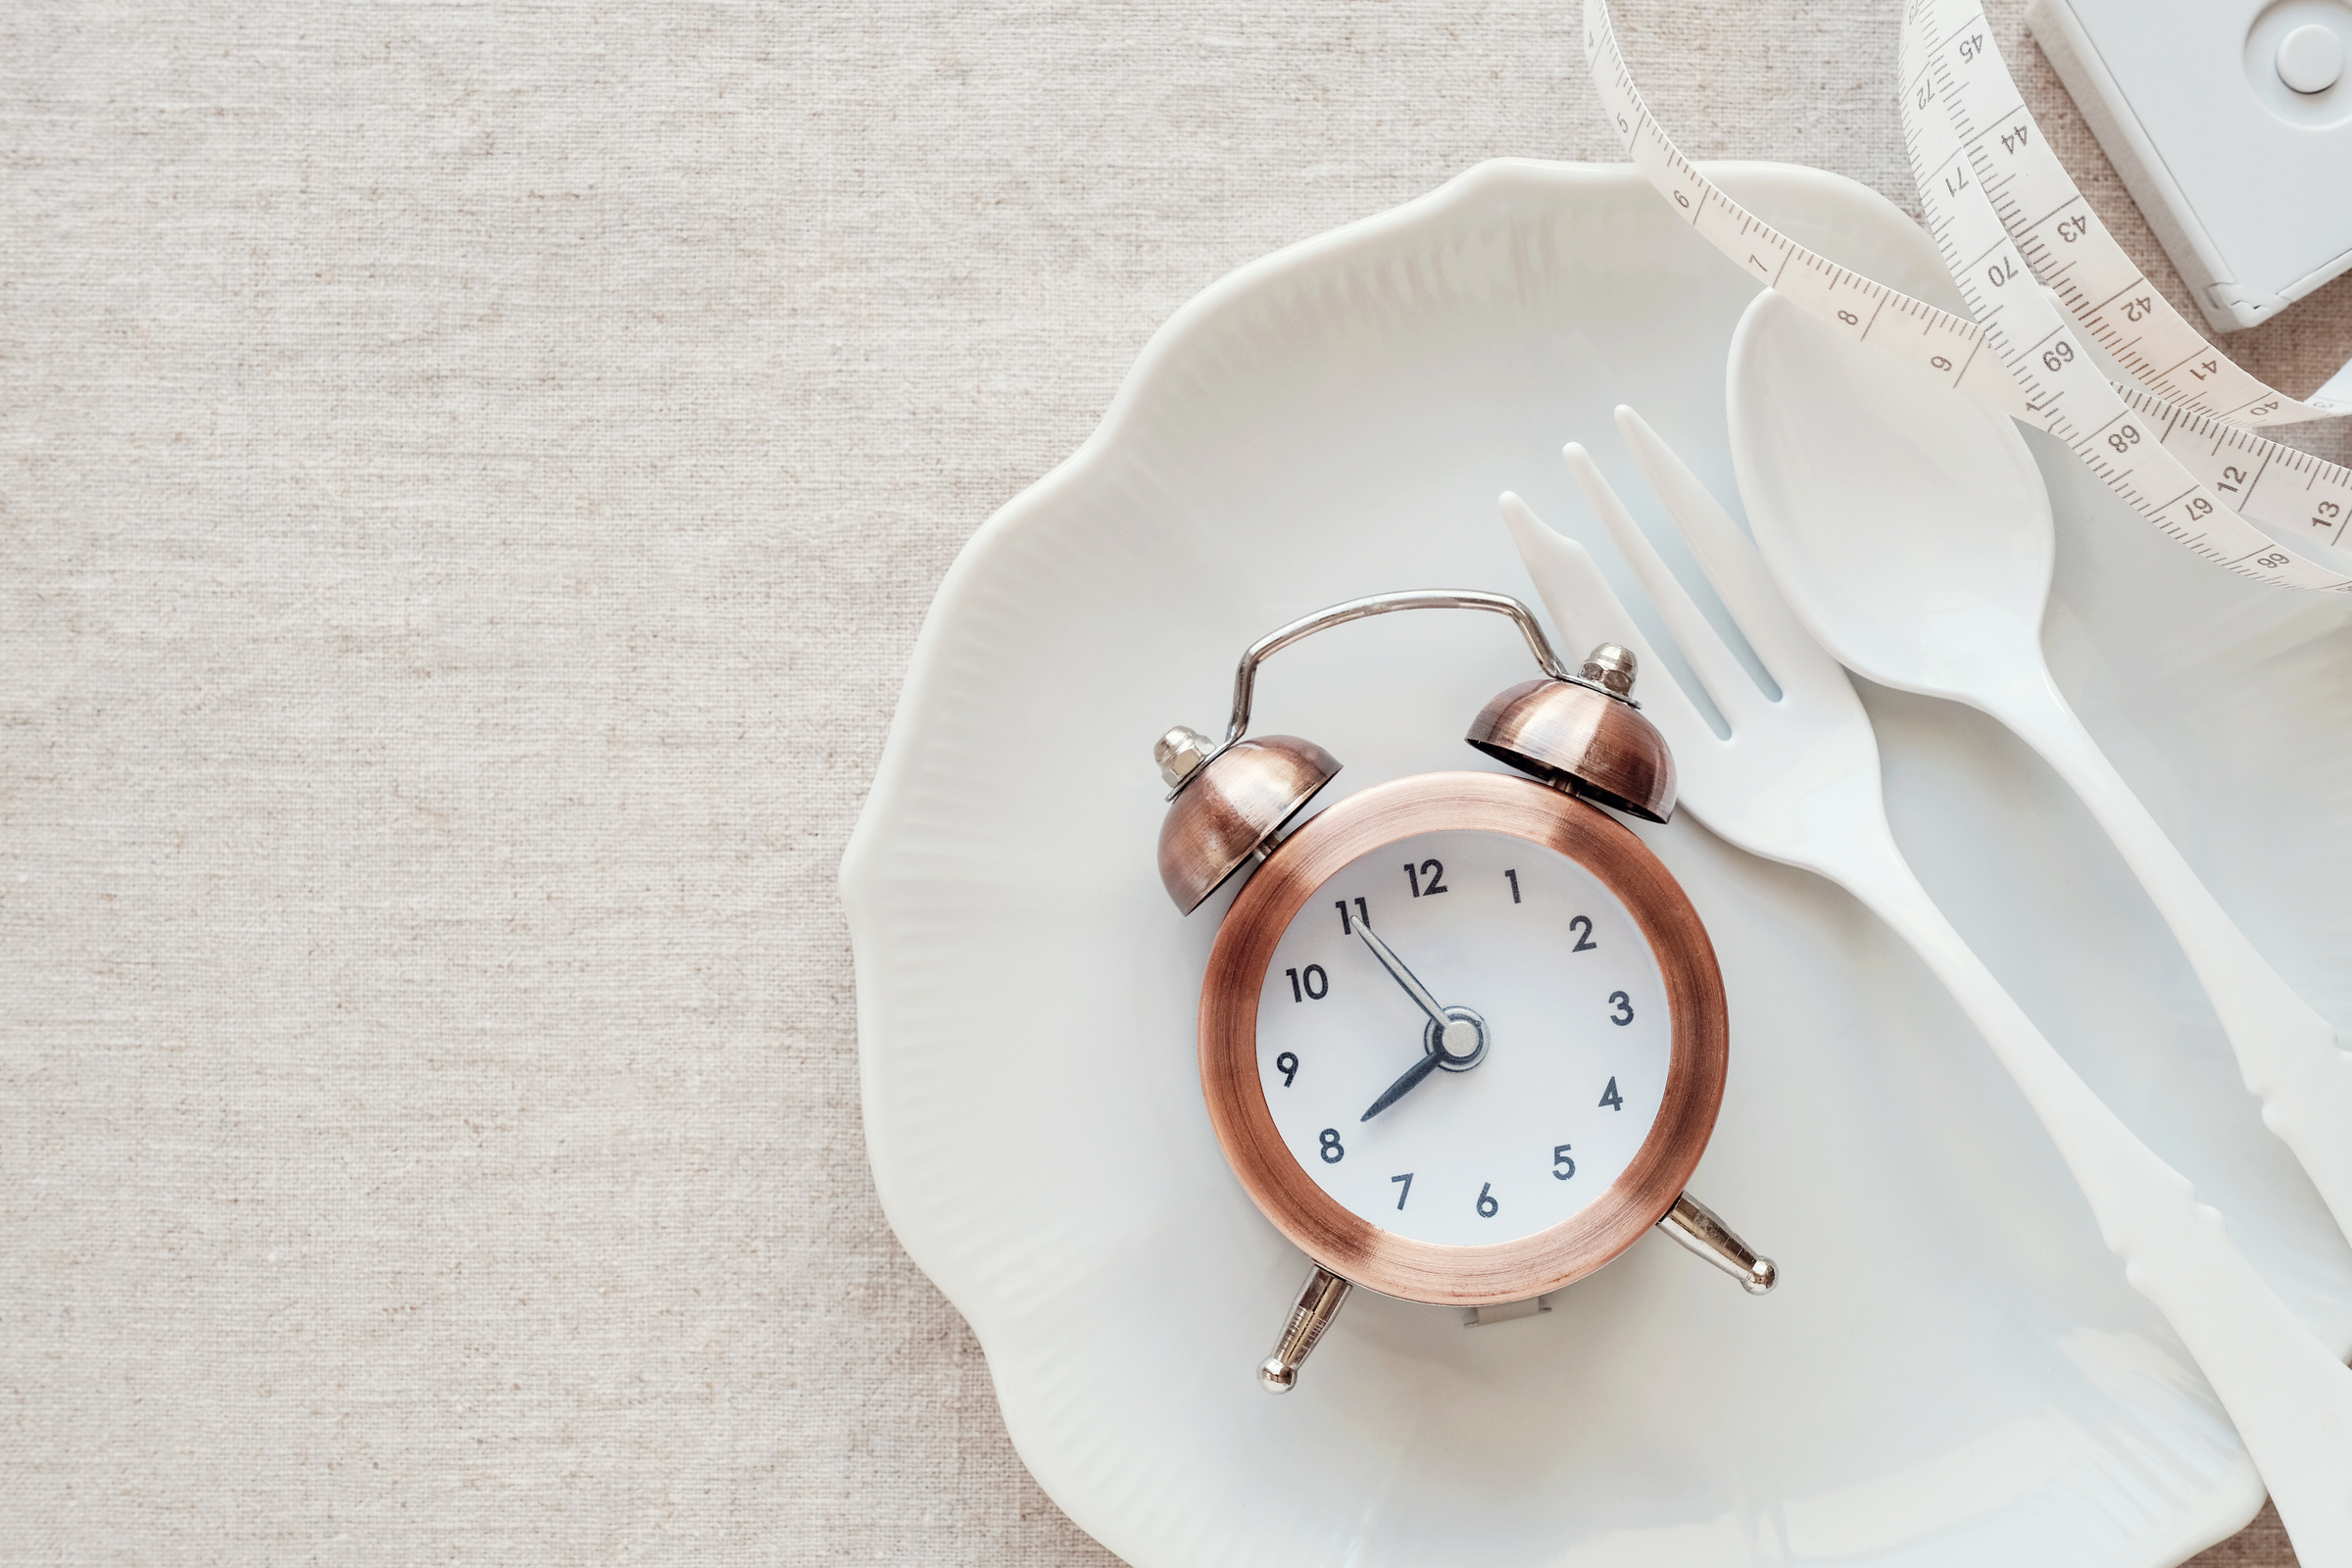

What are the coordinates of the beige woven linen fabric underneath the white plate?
(0, 0, 2352, 1566)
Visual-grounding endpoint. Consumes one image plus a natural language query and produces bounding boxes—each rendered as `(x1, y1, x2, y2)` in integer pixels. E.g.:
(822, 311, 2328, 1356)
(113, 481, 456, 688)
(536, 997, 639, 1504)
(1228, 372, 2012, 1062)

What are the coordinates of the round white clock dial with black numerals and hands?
(1256, 830, 1675, 1246)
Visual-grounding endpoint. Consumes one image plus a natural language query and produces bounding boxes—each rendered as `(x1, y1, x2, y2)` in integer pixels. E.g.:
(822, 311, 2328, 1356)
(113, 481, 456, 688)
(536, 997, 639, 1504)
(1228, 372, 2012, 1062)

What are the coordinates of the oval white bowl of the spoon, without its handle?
(1729, 289, 2056, 701)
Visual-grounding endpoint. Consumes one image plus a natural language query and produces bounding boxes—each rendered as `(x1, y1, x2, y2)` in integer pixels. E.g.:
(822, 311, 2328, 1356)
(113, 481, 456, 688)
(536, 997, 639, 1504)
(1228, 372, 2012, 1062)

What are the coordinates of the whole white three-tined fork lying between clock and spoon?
(1503, 409, 2352, 1568)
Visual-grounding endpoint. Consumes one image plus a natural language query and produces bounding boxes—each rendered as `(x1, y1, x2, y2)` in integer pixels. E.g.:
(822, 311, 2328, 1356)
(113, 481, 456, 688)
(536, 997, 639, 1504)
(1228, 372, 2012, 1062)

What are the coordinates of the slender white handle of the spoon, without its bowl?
(1992, 667, 2352, 1237)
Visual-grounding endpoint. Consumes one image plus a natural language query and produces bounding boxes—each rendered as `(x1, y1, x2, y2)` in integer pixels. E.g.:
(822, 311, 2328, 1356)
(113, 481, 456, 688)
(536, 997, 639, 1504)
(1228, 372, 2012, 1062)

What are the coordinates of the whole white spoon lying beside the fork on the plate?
(1721, 289, 2352, 1237)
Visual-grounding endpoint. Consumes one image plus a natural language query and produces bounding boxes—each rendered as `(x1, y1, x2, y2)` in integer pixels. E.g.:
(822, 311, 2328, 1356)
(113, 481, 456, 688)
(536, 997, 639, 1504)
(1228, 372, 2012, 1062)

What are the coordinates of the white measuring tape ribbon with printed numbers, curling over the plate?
(1586, 0, 2352, 592)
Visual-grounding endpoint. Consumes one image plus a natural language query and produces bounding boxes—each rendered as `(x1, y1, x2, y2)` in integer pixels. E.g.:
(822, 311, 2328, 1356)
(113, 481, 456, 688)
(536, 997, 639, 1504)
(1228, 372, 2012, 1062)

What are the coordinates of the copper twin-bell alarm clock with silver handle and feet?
(1154, 590, 1778, 1394)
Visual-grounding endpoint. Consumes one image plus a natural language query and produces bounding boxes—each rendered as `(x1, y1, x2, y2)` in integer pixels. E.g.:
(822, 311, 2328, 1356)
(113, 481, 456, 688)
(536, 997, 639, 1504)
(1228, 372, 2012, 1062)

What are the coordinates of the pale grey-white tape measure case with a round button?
(2025, 0, 2352, 331)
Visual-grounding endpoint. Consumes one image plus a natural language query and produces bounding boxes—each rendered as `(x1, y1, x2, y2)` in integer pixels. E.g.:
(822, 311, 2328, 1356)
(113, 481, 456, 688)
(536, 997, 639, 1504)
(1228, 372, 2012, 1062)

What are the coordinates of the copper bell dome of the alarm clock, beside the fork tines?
(1458, 642, 1675, 842)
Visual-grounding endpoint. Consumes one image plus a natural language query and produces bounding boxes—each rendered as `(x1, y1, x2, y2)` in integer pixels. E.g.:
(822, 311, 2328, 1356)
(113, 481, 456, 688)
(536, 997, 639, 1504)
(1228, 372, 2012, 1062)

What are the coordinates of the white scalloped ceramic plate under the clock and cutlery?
(842, 163, 2352, 1568)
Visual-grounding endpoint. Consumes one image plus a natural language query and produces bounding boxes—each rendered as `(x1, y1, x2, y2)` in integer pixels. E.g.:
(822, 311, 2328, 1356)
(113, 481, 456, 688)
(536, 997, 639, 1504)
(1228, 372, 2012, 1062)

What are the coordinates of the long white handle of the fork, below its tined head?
(1835, 837, 2352, 1568)
